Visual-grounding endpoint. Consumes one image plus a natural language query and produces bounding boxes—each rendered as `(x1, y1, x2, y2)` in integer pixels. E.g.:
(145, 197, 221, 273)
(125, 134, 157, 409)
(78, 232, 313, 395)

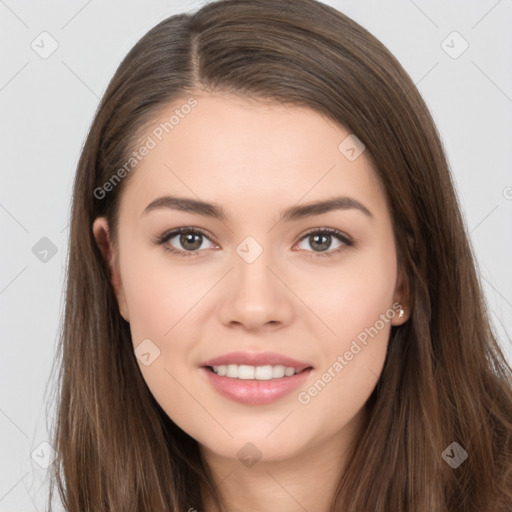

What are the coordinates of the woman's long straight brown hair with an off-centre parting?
(54, 0, 512, 512)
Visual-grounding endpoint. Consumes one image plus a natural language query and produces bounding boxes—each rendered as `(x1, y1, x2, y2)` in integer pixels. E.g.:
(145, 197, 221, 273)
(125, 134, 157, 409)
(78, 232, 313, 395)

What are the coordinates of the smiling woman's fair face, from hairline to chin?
(94, 94, 407, 464)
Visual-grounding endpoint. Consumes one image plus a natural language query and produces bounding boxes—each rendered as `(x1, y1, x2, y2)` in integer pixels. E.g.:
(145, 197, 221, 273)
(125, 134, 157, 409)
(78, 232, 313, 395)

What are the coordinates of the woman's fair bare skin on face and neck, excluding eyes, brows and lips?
(93, 92, 408, 512)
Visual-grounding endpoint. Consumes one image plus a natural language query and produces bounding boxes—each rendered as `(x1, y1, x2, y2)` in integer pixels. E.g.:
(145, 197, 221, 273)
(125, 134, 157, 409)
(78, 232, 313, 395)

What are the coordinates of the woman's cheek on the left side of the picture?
(121, 247, 208, 427)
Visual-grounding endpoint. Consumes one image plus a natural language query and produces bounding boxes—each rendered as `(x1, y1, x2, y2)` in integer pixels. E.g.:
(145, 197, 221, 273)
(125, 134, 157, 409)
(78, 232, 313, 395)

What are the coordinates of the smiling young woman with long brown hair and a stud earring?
(51, 0, 512, 512)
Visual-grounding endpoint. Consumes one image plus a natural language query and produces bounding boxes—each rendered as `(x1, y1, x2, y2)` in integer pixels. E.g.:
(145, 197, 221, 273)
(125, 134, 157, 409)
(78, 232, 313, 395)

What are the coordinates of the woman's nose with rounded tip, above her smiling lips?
(220, 244, 294, 331)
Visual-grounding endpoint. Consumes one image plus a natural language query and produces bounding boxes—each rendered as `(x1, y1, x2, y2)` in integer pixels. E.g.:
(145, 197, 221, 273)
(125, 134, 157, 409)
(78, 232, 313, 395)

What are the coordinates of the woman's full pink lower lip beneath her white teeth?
(201, 367, 312, 405)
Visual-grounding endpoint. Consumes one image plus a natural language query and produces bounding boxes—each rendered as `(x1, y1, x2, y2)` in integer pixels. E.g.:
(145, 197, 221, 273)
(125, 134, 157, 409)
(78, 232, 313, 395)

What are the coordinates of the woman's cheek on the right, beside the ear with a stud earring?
(290, 235, 397, 408)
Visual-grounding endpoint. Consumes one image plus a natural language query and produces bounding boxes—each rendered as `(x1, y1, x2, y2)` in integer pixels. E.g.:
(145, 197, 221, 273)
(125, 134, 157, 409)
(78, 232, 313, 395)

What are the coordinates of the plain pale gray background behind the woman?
(0, 0, 512, 512)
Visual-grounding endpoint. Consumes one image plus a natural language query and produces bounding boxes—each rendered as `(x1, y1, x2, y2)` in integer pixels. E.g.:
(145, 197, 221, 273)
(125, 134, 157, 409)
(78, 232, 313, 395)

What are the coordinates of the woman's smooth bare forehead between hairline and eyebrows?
(118, 93, 385, 218)
